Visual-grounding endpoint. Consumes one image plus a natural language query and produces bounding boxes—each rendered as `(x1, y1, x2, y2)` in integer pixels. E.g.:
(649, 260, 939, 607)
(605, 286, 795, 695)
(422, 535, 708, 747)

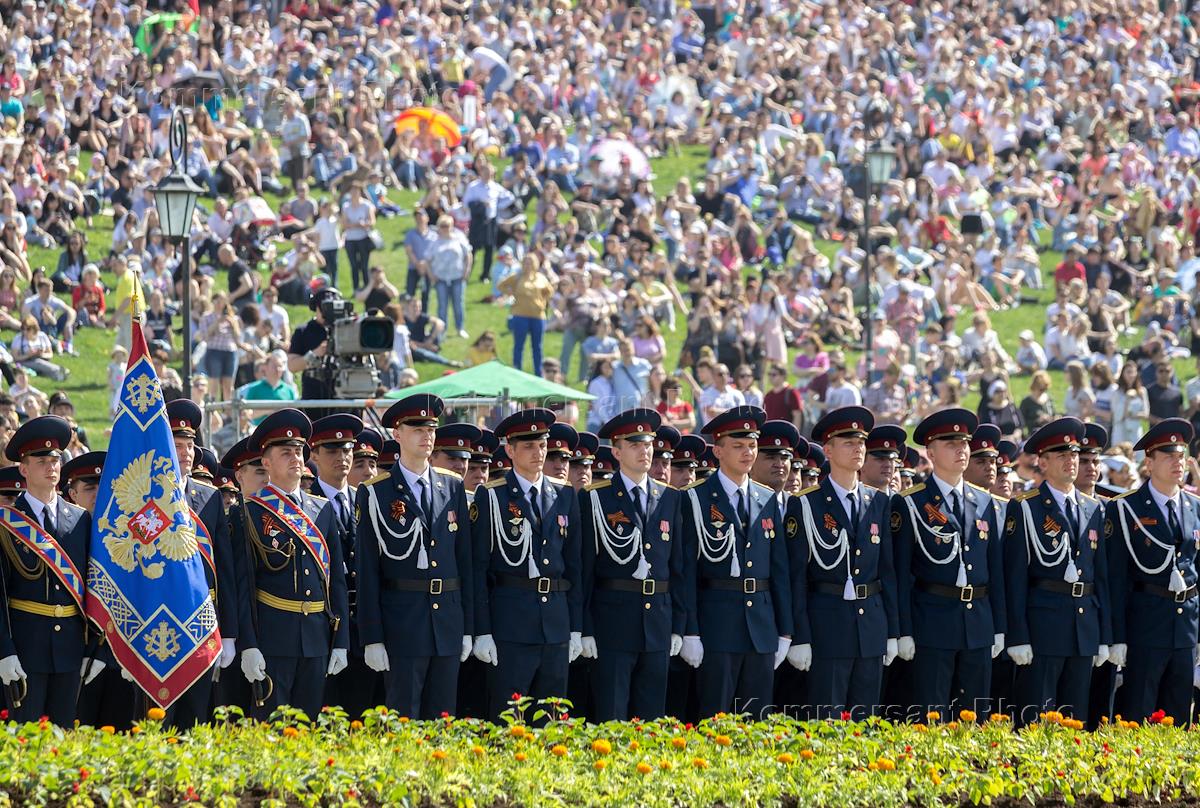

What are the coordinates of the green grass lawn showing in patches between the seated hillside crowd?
(18, 146, 1156, 448)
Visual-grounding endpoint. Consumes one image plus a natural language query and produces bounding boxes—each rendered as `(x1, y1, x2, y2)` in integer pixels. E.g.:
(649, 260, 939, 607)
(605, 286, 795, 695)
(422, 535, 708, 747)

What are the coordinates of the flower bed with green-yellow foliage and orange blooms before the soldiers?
(0, 704, 1200, 807)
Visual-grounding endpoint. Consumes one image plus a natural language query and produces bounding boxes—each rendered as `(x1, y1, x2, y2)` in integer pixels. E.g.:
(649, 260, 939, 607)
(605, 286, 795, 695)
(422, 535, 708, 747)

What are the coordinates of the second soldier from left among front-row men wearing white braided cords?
(470, 408, 583, 718)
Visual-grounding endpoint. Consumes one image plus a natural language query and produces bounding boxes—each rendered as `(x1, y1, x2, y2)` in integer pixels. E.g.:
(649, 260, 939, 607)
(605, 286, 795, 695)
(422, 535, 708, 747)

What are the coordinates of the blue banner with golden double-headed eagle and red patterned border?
(86, 323, 221, 708)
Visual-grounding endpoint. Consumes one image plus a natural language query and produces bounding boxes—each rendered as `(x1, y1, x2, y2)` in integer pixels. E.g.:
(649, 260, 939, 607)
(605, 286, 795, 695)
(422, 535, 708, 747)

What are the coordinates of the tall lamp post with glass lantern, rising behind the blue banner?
(154, 107, 204, 403)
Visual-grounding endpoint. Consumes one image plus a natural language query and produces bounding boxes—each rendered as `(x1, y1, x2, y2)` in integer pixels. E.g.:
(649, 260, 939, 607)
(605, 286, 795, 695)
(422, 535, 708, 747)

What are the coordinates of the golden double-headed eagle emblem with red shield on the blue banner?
(98, 450, 198, 579)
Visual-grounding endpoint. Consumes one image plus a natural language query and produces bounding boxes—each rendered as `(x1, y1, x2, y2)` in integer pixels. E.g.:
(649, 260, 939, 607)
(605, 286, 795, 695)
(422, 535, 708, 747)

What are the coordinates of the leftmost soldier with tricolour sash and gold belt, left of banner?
(0, 415, 93, 726)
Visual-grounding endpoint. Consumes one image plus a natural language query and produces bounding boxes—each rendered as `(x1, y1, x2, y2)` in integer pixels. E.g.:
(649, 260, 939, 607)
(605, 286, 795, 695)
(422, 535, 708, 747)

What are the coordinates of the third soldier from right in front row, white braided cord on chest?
(892, 408, 1006, 716)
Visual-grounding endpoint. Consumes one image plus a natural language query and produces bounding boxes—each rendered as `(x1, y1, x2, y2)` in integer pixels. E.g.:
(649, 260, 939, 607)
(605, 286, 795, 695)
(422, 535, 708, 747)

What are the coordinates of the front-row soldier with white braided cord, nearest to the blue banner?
(358, 394, 473, 719)
